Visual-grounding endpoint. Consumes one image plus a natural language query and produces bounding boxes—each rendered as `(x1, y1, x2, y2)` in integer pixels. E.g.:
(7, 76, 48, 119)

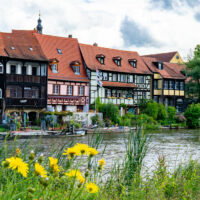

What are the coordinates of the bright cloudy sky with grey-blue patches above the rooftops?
(0, 0, 200, 60)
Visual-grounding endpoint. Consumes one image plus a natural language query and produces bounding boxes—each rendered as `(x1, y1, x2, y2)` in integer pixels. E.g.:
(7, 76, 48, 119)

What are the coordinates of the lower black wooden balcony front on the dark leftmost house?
(5, 98, 47, 109)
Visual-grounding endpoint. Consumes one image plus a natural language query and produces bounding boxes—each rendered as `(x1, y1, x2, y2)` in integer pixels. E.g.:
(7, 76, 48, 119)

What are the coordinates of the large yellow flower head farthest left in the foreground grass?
(6, 157, 29, 177)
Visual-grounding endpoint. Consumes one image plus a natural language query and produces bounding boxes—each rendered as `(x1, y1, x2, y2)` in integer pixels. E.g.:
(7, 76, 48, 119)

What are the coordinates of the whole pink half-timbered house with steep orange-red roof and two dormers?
(36, 33, 89, 112)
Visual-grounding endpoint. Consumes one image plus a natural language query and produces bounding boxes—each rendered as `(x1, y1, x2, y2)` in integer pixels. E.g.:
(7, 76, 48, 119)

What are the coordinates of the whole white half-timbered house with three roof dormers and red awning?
(80, 44, 152, 112)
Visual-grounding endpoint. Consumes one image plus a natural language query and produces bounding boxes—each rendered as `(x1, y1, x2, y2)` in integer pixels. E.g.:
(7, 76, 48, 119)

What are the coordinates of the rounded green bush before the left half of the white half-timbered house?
(99, 103, 119, 123)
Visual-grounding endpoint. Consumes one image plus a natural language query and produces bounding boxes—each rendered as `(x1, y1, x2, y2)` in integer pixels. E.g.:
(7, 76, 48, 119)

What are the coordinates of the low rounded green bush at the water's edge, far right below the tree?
(184, 103, 200, 128)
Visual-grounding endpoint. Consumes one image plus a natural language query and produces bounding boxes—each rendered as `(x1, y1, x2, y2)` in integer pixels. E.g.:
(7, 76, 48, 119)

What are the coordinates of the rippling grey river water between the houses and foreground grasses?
(0, 129, 200, 173)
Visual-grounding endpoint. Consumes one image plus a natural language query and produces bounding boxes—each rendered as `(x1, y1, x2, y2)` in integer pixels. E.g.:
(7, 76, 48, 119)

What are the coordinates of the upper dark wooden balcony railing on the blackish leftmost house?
(6, 74, 47, 84)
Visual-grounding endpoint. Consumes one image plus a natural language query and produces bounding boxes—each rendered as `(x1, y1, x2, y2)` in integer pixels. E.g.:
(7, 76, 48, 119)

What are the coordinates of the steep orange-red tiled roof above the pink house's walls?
(35, 33, 89, 82)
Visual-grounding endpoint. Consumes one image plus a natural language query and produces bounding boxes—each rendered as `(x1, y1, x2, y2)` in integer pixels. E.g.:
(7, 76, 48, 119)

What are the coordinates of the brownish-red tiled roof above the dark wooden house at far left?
(0, 30, 48, 61)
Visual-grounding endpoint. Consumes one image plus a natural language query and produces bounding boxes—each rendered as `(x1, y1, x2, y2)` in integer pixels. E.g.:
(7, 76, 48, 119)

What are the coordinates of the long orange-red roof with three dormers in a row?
(80, 44, 151, 74)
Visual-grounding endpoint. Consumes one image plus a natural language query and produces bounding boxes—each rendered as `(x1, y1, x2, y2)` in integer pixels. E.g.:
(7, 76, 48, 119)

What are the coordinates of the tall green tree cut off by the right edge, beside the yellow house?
(186, 45, 200, 102)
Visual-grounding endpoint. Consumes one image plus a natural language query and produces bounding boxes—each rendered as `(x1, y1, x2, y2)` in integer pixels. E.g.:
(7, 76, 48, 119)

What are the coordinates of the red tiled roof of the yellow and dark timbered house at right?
(142, 56, 186, 79)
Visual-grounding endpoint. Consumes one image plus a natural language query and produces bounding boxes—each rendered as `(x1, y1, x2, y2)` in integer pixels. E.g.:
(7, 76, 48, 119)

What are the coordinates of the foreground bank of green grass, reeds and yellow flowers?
(0, 130, 200, 200)
